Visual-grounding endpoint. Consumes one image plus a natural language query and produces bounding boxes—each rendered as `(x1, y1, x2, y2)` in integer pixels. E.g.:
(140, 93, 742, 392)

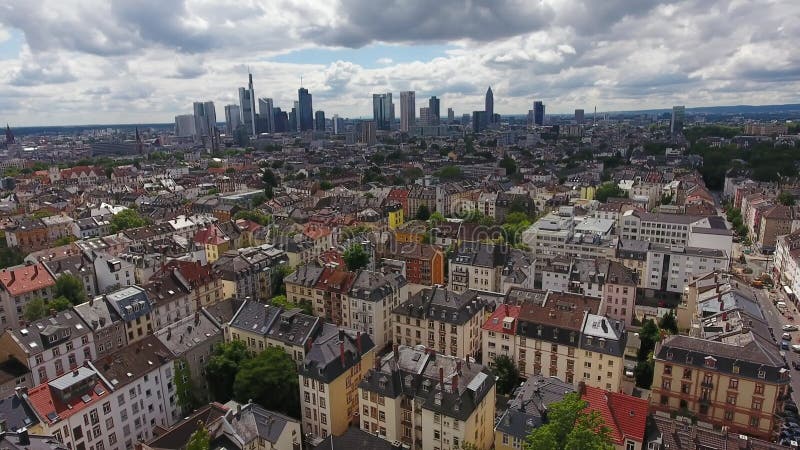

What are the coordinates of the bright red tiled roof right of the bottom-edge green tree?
(581, 386, 648, 445)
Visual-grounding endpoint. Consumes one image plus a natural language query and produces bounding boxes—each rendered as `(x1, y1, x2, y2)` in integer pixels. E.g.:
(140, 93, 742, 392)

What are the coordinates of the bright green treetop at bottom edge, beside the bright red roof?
(523, 392, 614, 450)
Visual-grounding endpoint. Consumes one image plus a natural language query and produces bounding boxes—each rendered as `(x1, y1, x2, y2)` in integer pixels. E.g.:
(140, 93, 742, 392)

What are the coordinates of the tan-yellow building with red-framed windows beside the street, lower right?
(650, 334, 790, 439)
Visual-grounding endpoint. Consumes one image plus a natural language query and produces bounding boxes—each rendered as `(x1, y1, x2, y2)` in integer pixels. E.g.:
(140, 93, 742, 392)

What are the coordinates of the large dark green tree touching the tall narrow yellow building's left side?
(238, 347, 300, 418)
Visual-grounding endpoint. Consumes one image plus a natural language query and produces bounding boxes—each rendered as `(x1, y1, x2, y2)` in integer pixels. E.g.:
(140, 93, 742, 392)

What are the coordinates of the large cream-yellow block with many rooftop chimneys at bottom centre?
(358, 346, 495, 450)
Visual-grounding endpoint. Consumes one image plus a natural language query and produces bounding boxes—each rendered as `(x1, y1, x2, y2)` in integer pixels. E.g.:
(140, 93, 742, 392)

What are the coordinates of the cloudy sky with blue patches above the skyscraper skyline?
(0, 0, 800, 127)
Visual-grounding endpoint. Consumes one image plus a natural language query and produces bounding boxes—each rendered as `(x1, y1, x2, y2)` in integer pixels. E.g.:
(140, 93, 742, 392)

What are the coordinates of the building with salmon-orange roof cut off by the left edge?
(0, 263, 56, 330)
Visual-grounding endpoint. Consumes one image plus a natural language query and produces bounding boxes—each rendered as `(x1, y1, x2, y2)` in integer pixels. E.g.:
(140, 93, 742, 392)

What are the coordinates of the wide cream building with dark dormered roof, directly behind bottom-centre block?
(392, 286, 489, 359)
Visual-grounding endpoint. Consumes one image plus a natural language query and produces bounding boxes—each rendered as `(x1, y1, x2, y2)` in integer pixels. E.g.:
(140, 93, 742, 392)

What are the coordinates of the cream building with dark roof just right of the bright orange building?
(448, 242, 509, 293)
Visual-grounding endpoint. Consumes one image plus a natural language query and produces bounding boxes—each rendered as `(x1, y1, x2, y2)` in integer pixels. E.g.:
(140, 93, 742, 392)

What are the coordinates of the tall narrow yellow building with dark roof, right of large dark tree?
(298, 324, 375, 438)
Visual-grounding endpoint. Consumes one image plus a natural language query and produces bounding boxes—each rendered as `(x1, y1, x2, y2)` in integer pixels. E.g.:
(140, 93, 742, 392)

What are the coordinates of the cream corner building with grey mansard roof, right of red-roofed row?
(342, 270, 409, 349)
